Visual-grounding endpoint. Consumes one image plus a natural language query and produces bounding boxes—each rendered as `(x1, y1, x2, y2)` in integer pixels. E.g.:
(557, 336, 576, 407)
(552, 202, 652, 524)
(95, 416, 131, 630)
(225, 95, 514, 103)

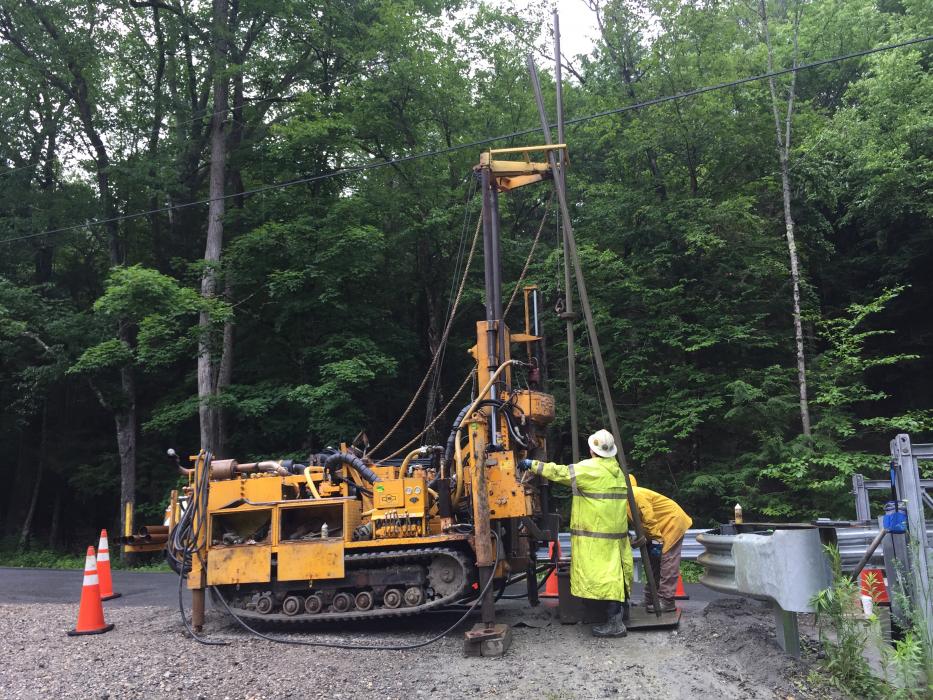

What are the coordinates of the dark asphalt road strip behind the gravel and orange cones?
(0, 567, 723, 610)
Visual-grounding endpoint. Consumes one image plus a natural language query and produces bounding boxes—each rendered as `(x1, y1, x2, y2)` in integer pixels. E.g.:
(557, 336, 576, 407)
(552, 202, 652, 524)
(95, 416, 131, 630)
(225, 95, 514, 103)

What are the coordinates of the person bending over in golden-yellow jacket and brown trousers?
(629, 486, 693, 612)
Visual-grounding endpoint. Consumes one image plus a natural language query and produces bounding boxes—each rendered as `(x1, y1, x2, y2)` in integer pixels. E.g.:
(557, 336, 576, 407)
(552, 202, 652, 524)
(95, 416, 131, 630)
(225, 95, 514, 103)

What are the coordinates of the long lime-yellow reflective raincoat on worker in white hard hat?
(531, 457, 628, 601)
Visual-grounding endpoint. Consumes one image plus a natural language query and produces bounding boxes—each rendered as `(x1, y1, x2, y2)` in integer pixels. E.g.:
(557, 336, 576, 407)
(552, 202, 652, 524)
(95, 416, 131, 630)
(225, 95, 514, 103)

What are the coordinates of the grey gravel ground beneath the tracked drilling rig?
(0, 598, 826, 700)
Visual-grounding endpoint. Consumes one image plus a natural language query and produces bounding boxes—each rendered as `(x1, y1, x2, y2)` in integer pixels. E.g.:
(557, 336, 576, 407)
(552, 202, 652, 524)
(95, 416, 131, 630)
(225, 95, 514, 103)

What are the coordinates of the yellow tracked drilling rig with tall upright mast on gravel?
(168, 144, 566, 648)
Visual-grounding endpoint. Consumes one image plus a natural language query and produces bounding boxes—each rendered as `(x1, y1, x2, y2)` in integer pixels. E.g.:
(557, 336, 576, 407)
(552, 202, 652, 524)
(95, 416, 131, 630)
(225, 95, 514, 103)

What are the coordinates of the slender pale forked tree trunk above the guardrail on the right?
(758, 0, 811, 437)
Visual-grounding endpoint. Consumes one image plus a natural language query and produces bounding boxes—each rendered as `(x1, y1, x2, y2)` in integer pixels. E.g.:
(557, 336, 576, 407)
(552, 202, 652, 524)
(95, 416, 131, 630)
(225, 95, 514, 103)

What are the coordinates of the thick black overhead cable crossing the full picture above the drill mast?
(0, 35, 933, 249)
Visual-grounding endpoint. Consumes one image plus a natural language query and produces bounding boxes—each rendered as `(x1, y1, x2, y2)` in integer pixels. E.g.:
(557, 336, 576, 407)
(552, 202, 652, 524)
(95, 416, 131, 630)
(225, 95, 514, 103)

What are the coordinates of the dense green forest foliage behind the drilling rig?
(0, 0, 933, 545)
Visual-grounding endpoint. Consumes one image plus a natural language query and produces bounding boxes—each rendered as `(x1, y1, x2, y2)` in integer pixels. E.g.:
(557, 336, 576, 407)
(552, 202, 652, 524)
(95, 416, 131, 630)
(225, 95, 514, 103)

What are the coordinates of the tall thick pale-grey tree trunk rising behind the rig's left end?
(198, 0, 227, 449)
